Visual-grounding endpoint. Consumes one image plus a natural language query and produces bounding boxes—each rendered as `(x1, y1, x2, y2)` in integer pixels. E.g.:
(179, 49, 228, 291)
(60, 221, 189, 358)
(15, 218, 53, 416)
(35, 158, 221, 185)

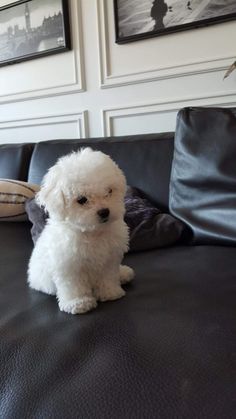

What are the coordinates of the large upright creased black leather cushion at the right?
(169, 107, 236, 245)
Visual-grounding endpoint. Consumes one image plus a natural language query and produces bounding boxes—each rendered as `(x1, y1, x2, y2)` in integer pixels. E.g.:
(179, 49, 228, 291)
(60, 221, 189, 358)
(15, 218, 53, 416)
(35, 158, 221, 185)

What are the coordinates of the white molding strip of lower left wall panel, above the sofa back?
(0, 111, 89, 138)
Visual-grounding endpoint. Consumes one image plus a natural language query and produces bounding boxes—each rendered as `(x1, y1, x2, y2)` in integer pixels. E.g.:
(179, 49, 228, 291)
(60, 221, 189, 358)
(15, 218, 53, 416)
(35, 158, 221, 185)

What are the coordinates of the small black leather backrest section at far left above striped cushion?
(0, 144, 33, 181)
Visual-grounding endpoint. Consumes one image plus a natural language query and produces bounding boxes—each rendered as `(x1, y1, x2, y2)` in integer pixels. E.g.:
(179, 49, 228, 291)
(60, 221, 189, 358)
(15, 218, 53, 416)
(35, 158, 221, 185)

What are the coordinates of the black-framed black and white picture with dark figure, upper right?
(114, 0, 236, 44)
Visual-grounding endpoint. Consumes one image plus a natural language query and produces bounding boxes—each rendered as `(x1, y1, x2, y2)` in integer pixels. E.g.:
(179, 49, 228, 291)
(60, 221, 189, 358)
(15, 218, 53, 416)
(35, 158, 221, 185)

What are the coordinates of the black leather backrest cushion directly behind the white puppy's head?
(28, 133, 174, 210)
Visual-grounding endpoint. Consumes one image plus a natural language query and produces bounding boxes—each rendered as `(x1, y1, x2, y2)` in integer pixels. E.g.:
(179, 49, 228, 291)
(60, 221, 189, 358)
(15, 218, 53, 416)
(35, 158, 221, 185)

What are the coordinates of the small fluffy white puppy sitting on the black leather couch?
(28, 148, 134, 314)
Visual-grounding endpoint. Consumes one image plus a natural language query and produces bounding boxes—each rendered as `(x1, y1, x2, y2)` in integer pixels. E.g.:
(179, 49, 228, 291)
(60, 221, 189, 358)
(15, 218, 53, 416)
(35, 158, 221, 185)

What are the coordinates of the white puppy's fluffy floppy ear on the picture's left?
(36, 164, 66, 219)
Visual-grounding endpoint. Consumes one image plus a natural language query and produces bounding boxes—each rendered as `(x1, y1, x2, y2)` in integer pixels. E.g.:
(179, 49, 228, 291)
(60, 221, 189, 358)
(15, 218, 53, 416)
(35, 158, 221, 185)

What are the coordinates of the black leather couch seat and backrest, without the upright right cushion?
(0, 112, 236, 419)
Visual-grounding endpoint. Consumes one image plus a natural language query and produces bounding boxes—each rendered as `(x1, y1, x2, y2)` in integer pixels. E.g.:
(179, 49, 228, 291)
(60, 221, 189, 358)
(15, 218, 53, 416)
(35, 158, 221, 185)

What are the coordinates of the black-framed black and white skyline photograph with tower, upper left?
(0, 0, 70, 66)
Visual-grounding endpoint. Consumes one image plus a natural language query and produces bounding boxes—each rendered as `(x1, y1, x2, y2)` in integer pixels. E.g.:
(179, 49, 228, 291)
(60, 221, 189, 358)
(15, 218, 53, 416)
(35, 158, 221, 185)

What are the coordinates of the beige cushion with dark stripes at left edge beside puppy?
(0, 179, 39, 221)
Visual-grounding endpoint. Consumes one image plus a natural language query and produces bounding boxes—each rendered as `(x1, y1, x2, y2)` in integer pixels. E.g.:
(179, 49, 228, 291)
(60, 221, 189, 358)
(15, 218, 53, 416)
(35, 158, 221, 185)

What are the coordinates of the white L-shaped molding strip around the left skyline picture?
(0, 0, 86, 104)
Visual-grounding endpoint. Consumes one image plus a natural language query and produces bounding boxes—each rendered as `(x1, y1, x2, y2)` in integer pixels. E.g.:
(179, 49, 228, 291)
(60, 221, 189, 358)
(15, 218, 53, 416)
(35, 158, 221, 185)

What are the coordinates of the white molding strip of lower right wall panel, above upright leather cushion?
(101, 90, 236, 137)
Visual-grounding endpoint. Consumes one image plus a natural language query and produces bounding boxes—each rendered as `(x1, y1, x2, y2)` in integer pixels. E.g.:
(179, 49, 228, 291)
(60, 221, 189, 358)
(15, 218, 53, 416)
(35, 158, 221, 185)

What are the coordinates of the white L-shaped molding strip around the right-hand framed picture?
(97, 0, 235, 89)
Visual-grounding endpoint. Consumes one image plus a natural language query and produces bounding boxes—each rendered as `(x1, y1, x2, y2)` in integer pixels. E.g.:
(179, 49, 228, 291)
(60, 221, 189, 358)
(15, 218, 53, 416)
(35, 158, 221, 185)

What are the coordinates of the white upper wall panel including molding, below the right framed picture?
(97, 0, 235, 88)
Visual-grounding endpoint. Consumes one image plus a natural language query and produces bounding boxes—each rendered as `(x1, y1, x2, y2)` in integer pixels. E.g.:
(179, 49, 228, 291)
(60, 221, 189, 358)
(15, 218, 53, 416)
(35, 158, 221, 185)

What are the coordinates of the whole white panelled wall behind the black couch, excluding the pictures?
(0, 0, 236, 142)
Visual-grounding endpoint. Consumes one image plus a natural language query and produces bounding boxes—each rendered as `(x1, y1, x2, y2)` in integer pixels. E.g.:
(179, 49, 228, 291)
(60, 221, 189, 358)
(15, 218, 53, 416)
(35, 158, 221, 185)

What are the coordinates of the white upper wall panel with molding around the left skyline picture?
(0, 0, 85, 104)
